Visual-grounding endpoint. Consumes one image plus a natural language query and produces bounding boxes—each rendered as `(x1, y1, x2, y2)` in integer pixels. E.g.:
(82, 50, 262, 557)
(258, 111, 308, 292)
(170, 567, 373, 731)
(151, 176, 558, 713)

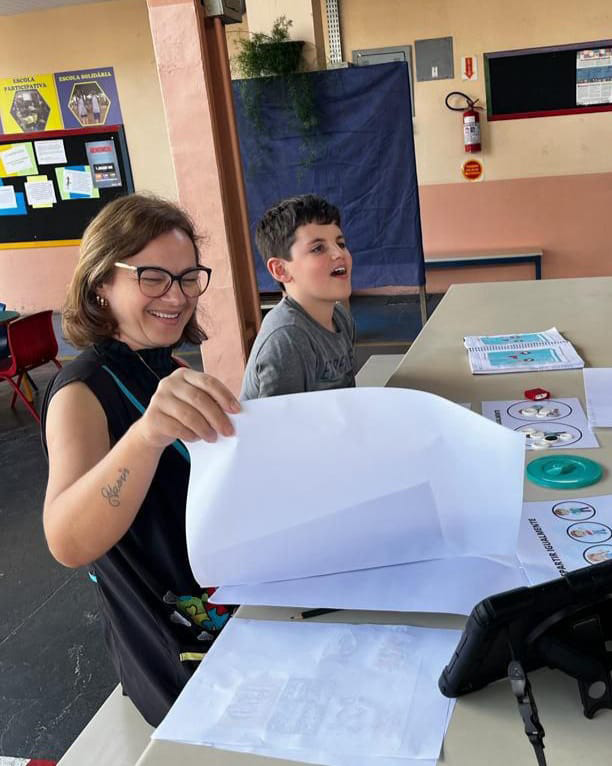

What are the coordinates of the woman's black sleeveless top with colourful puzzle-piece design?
(41, 340, 229, 726)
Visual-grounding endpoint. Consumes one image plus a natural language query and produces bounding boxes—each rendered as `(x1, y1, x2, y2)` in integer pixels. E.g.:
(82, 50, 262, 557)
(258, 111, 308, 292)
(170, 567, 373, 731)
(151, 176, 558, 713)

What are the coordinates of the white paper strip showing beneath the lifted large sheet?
(211, 556, 529, 615)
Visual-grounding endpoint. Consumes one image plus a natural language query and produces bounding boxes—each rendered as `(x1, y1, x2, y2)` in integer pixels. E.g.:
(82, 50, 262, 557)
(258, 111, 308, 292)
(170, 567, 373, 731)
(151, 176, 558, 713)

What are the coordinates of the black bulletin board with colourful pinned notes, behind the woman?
(0, 125, 134, 248)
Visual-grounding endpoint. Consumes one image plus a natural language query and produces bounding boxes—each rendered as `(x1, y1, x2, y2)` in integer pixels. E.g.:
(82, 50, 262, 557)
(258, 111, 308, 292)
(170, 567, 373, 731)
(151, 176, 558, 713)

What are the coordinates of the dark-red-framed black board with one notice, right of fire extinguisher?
(484, 40, 612, 121)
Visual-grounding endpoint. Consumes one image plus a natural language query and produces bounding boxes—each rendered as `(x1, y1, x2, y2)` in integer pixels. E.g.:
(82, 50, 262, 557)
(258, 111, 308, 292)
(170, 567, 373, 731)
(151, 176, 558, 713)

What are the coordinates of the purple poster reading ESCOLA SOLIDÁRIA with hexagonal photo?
(55, 67, 123, 130)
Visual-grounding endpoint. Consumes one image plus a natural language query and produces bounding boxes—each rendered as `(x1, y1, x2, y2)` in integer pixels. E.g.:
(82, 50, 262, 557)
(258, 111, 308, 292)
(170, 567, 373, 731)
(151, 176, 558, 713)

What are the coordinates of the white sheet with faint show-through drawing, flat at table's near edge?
(153, 618, 461, 766)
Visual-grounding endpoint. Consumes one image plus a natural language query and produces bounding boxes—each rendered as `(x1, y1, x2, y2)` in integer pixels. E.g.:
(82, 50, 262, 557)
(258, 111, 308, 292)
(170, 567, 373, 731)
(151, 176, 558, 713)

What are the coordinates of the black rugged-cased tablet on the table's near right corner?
(439, 561, 612, 718)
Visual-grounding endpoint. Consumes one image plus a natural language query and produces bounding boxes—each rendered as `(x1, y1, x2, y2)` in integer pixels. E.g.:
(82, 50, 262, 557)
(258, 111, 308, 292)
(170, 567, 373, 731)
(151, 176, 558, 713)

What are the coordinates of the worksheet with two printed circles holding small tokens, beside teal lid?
(482, 398, 599, 450)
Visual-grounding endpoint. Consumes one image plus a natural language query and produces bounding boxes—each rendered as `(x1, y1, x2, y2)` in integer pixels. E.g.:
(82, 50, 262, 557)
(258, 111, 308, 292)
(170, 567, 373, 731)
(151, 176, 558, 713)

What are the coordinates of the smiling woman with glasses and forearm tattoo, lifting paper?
(41, 194, 240, 726)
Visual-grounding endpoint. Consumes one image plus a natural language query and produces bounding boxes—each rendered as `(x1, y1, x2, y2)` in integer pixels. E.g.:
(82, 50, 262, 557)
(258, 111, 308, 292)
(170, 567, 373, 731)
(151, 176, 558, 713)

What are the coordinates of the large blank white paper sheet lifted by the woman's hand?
(187, 388, 524, 585)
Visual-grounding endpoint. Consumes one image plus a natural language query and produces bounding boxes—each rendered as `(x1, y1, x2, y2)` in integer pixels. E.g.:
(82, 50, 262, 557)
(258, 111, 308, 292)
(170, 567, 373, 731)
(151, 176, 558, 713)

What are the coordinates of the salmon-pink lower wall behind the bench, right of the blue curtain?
(419, 173, 612, 292)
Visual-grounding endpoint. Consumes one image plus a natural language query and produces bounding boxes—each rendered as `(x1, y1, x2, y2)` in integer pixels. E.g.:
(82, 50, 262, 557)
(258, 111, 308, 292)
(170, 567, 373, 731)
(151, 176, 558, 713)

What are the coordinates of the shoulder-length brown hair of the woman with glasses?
(62, 194, 206, 348)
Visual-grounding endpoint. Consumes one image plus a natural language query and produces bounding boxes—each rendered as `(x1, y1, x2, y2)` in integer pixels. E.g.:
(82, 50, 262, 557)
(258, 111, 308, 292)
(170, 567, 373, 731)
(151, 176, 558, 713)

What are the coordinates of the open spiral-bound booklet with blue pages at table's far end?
(464, 327, 584, 375)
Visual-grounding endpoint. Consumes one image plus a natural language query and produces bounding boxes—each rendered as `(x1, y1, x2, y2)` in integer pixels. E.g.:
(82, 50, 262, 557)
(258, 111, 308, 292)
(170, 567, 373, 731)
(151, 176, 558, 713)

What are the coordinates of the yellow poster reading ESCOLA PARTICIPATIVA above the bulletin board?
(0, 74, 64, 133)
